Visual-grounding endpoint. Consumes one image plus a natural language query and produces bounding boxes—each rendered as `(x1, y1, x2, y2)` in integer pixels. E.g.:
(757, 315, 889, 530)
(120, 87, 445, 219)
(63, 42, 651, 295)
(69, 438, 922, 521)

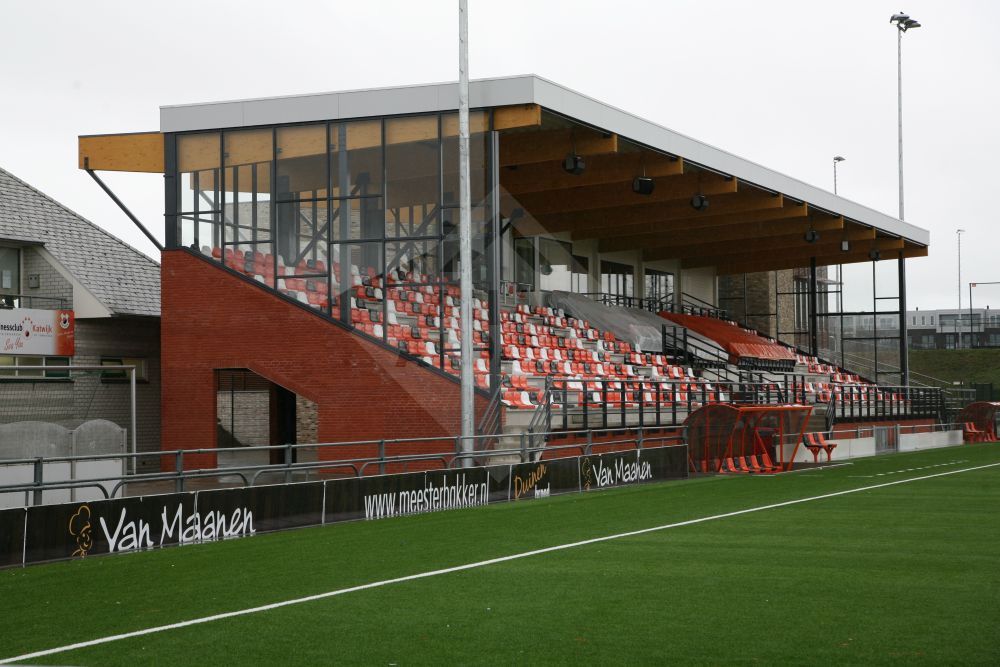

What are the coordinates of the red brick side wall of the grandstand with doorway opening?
(160, 250, 486, 472)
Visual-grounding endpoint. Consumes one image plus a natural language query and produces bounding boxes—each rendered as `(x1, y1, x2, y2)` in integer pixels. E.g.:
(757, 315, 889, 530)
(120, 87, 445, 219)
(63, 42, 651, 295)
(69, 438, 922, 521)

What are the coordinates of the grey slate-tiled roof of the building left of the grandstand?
(0, 169, 160, 316)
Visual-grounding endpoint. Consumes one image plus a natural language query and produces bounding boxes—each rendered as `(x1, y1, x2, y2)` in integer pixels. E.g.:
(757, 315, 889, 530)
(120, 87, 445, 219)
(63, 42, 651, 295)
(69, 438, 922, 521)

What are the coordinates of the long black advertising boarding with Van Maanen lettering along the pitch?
(0, 445, 688, 567)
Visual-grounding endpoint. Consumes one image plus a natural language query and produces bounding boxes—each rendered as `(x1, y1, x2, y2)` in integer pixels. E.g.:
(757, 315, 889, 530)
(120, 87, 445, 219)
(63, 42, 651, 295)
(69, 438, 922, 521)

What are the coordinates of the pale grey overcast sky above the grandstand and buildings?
(0, 0, 1000, 309)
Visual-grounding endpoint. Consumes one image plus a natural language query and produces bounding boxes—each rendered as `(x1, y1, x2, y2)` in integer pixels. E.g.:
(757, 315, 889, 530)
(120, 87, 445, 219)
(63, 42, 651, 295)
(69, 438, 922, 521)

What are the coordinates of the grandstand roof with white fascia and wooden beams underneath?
(80, 75, 930, 273)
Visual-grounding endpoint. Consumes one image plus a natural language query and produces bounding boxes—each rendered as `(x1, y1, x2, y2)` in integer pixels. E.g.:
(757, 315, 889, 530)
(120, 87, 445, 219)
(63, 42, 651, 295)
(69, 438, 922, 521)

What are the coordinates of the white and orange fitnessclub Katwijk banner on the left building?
(0, 308, 76, 357)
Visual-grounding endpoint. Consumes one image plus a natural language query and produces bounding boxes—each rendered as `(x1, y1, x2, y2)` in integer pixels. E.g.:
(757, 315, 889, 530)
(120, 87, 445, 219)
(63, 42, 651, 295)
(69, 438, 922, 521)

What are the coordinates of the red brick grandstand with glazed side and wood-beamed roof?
(80, 76, 928, 466)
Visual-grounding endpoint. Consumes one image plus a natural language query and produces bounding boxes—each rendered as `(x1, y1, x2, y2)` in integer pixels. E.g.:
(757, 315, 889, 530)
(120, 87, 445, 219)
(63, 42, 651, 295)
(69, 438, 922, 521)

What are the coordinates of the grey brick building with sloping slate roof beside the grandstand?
(0, 169, 160, 465)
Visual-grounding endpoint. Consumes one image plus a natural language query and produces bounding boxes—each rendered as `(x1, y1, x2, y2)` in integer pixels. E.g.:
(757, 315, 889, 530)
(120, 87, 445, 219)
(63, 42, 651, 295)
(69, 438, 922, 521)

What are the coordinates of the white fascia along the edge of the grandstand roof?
(160, 74, 930, 245)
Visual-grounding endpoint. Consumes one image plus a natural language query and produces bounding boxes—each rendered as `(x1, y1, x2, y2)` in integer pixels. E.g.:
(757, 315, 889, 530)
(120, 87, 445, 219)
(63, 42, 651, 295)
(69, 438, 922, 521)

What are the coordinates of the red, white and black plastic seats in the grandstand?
(202, 247, 898, 420)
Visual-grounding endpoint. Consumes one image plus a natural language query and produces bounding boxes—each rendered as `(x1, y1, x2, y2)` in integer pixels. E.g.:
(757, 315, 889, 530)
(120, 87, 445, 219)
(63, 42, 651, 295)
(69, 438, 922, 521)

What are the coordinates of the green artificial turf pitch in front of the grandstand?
(0, 444, 1000, 665)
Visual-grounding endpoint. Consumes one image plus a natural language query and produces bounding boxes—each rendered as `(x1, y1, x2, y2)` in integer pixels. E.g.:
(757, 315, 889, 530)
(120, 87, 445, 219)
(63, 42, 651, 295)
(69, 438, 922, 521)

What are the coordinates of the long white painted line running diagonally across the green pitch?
(0, 462, 1000, 665)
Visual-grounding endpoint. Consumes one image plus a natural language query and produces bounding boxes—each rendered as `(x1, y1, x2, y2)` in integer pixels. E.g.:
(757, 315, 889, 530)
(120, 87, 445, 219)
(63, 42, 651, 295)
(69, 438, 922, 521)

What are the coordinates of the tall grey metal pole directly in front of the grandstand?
(458, 0, 476, 467)
